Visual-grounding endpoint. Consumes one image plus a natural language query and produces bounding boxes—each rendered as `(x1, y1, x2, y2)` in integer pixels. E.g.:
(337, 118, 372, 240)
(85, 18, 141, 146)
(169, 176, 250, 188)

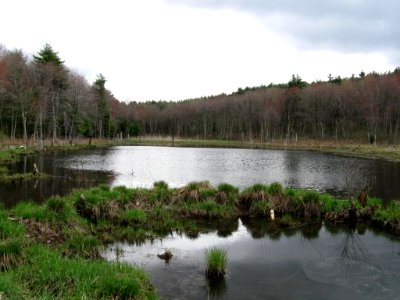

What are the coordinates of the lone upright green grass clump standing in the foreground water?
(204, 247, 228, 278)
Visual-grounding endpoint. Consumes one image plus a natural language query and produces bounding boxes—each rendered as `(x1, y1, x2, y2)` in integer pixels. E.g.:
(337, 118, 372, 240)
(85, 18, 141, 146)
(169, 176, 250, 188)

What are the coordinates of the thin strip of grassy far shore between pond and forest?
(0, 137, 400, 163)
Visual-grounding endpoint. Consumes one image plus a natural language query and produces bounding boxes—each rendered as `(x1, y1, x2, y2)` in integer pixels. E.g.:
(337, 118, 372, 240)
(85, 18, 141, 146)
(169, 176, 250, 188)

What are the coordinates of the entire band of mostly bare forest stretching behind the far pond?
(0, 44, 400, 147)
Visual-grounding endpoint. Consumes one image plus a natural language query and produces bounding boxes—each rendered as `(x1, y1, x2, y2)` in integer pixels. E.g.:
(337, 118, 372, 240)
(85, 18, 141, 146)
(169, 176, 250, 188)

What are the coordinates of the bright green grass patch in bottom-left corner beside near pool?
(4, 245, 156, 299)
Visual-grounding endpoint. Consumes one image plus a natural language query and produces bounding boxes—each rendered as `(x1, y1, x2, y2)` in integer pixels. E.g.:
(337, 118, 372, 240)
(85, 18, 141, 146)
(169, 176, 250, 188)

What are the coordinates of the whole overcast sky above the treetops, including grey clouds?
(0, 0, 400, 101)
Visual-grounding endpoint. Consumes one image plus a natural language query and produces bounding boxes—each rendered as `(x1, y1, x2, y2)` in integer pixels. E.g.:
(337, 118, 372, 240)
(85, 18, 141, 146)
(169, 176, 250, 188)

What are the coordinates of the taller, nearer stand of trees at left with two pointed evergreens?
(0, 44, 135, 147)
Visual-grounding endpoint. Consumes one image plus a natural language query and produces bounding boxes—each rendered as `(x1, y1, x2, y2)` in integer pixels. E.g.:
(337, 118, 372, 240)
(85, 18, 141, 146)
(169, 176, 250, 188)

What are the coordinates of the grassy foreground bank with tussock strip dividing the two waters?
(0, 181, 400, 299)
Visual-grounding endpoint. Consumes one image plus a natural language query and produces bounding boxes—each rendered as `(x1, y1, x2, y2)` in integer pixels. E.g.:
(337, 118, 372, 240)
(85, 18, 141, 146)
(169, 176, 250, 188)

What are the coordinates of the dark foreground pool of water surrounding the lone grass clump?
(103, 219, 400, 300)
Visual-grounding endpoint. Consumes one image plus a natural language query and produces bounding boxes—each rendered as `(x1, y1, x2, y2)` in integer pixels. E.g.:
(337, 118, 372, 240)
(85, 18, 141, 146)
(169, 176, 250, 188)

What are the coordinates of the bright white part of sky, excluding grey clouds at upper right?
(0, 0, 394, 101)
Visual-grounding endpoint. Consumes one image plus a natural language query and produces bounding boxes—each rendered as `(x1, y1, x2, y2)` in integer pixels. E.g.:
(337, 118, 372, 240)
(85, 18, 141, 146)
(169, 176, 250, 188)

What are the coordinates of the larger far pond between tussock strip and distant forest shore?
(0, 146, 400, 205)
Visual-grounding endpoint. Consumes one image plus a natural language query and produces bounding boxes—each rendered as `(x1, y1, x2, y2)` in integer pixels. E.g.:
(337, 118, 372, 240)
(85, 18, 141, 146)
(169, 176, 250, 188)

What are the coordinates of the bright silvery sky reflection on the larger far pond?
(57, 146, 400, 196)
